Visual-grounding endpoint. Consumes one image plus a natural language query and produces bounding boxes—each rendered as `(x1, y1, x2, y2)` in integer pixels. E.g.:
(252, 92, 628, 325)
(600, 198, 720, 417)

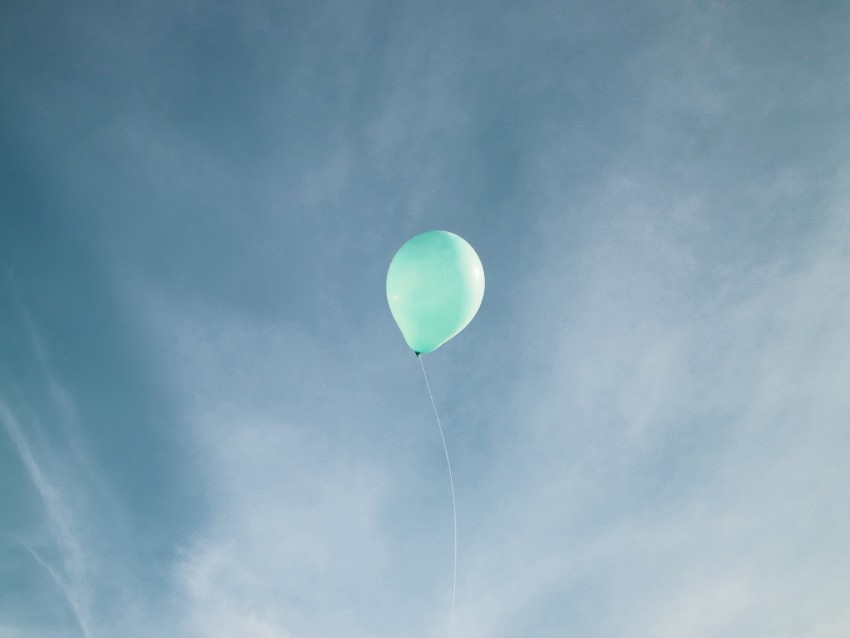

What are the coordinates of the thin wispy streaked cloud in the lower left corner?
(0, 288, 171, 638)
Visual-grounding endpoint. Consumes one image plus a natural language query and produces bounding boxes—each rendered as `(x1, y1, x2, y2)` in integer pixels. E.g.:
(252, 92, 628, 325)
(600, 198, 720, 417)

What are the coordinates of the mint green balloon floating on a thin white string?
(387, 230, 484, 355)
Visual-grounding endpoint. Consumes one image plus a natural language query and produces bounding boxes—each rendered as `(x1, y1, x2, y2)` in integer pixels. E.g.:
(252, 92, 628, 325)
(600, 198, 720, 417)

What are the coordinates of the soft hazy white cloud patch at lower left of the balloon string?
(132, 300, 430, 636)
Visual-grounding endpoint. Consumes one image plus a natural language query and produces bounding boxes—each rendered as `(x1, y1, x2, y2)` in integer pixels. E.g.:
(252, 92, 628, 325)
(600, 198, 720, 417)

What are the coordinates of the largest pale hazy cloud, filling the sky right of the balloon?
(444, 159, 850, 636)
